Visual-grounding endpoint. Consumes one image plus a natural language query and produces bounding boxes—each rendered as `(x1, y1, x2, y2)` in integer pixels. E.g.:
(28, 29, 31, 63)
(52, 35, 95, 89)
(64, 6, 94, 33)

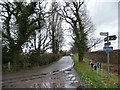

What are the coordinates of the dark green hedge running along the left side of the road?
(3, 54, 62, 71)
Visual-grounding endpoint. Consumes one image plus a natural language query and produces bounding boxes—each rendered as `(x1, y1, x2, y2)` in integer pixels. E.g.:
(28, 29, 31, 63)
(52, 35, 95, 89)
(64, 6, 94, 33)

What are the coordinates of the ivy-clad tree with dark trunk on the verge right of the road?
(61, 0, 87, 61)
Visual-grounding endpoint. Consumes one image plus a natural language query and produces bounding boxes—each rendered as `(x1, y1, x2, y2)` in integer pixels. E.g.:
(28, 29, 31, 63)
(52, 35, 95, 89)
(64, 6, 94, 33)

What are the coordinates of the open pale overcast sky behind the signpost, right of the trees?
(87, 0, 119, 50)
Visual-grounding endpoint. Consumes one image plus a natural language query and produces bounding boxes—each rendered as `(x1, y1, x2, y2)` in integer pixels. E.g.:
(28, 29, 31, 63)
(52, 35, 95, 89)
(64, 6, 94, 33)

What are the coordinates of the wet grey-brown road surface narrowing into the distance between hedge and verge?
(2, 56, 85, 88)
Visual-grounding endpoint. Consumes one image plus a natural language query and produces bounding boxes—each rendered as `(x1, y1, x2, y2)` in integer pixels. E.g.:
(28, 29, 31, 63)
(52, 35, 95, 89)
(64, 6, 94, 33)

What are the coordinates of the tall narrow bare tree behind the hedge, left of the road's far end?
(49, 1, 64, 53)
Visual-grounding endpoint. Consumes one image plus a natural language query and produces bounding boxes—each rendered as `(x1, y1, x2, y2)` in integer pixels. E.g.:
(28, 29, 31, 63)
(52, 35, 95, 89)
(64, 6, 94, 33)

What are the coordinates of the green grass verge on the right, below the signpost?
(73, 54, 118, 88)
